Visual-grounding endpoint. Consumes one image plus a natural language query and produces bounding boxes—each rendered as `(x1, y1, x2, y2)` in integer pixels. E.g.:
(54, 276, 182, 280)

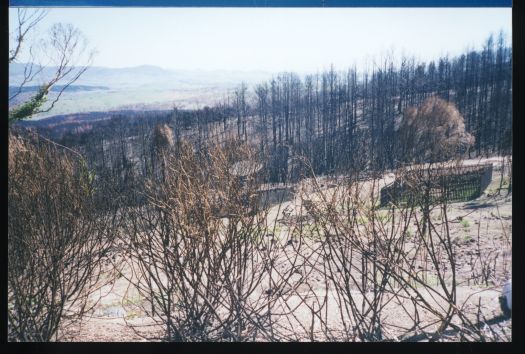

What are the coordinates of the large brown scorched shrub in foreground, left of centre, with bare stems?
(125, 142, 302, 341)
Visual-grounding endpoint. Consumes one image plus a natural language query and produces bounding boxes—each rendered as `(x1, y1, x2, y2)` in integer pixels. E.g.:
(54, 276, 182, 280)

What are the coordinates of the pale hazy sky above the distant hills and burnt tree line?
(10, 8, 512, 72)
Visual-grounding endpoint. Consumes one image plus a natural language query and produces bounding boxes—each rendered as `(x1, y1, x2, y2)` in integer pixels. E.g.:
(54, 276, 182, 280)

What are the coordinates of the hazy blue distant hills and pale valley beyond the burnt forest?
(9, 63, 273, 118)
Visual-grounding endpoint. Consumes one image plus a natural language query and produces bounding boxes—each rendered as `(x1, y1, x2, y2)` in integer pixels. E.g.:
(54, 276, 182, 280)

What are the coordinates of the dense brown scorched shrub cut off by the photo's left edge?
(8, 136, 117, 341)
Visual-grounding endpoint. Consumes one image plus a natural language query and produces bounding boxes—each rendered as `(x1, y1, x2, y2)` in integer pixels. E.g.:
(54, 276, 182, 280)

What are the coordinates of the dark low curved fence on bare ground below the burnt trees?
(381, 164, 492, 206)
